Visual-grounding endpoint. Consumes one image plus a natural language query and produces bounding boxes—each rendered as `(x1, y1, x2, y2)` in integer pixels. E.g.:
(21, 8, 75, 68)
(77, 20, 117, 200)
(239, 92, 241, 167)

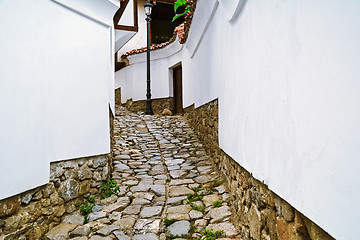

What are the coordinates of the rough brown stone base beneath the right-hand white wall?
(184, 99, 333, 240)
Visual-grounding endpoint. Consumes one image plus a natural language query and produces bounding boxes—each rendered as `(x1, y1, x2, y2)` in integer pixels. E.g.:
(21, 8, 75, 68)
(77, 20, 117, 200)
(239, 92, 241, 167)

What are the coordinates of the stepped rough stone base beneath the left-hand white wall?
(0, 155, 110, 240)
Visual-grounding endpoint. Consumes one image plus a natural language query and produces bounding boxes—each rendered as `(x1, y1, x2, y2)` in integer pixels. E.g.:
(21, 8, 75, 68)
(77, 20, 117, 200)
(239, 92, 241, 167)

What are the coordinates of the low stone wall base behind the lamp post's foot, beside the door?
(125, 97, 174, 114)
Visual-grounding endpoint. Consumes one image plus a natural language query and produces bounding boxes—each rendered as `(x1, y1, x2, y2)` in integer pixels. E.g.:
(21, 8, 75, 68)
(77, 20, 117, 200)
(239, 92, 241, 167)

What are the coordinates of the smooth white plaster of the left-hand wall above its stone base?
(0, 0, 114, 199)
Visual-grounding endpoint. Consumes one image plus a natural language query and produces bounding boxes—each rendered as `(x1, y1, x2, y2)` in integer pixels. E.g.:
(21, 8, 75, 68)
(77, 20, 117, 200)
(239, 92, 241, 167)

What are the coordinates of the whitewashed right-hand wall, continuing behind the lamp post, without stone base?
(116, 0, 360, 239)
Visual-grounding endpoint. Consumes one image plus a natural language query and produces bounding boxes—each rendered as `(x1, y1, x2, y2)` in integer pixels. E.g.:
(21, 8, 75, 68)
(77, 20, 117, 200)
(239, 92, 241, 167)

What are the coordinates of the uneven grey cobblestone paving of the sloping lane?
(46, 108, 239, 240)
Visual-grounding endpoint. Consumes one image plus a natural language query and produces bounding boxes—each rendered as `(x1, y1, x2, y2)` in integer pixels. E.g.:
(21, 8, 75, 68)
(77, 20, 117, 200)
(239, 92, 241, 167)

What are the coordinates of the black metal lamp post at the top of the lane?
(144, 1, 154, 115)
